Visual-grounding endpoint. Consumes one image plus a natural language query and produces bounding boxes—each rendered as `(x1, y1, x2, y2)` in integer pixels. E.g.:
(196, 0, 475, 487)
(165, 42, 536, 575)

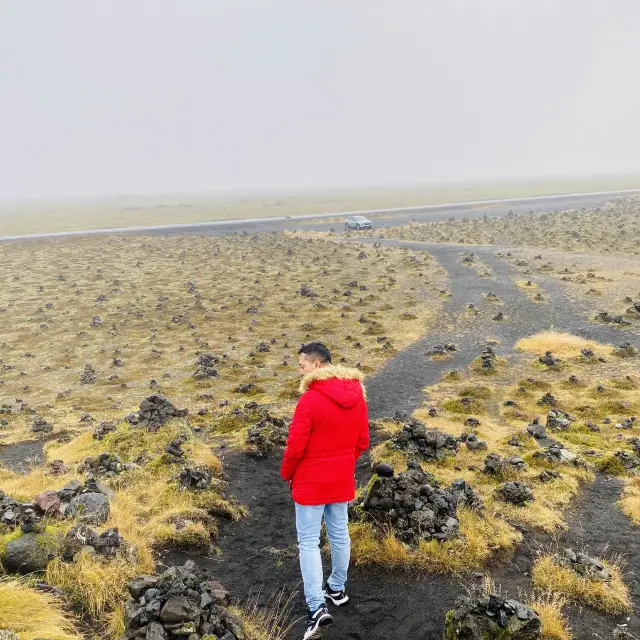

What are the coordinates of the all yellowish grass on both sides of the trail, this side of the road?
(0, 210, 640, 640)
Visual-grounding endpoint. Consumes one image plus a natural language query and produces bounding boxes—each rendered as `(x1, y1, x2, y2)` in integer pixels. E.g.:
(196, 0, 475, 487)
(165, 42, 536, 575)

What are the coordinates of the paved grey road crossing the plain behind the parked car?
(0, 190, 640, 242)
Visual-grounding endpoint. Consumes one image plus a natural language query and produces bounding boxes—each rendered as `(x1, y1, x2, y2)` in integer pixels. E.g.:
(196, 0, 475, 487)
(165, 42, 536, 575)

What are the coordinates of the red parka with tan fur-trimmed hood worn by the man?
(280, 366, 369, 505)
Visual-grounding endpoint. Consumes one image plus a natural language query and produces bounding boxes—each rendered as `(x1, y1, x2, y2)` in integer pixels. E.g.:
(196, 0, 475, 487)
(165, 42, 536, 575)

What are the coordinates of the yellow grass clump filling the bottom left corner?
(0, 579, 82, 640)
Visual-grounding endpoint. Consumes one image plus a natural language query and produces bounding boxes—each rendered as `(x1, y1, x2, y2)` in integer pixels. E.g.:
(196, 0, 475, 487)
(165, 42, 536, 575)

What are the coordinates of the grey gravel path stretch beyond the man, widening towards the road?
(367, 240, 639, 418)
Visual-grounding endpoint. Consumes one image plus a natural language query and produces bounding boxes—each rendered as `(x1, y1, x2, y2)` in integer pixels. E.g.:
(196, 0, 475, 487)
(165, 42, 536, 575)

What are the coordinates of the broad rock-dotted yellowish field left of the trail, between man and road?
(0, 235, 445, 442)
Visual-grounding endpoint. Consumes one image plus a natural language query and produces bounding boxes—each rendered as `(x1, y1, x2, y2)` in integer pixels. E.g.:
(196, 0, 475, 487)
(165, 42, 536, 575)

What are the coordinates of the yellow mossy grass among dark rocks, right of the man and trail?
(352, 331, 640, 576)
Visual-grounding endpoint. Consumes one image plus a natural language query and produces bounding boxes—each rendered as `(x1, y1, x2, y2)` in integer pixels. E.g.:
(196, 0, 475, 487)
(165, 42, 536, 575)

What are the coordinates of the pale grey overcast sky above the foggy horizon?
(0, 0, 640, 198)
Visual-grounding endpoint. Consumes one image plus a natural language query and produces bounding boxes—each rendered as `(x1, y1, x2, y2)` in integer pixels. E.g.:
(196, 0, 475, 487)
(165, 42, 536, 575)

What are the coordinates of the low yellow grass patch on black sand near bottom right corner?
(531, 555, 633, 614)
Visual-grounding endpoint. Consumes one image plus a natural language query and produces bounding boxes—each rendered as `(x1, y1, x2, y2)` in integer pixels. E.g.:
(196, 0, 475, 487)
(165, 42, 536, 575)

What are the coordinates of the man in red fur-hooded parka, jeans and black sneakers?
(280, 342, 369, 640)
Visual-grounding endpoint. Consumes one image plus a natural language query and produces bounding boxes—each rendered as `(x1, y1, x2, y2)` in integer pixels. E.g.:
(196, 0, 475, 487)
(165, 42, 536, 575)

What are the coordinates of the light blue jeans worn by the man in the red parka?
(296, 502, 351, 611)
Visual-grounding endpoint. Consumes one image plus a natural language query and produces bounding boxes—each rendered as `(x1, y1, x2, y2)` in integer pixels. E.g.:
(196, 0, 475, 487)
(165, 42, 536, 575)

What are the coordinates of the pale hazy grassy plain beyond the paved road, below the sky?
(0, 176, 640, 235)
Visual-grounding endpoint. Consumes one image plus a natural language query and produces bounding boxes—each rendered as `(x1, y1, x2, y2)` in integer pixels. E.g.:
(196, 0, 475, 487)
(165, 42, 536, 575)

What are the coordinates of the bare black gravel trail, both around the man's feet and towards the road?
(160, 241, 640, 640)
